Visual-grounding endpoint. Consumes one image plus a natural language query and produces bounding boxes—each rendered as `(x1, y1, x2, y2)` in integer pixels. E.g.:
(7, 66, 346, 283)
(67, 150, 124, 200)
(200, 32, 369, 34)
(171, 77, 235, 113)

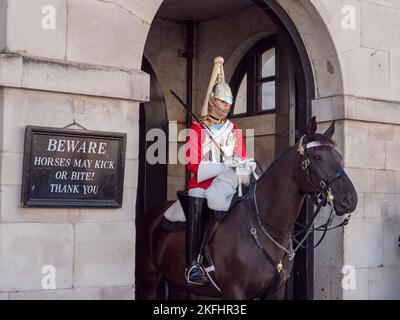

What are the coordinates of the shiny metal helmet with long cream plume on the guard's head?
(201, 57, 233, 117)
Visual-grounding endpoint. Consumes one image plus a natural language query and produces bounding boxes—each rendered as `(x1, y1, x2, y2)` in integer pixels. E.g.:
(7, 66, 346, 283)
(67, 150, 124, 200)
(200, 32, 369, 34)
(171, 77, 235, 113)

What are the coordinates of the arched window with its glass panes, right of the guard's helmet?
(231, 36, 276, 116)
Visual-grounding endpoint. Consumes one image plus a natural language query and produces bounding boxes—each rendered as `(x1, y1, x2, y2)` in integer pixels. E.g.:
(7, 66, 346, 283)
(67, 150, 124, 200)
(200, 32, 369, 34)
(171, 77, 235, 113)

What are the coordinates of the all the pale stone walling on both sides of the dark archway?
(0, 0, 400, 299)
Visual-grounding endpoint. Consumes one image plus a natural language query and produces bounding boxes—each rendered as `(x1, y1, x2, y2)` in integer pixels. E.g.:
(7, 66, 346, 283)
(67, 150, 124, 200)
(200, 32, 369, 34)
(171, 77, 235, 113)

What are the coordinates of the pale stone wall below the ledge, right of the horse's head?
(343, 117, 400, 299)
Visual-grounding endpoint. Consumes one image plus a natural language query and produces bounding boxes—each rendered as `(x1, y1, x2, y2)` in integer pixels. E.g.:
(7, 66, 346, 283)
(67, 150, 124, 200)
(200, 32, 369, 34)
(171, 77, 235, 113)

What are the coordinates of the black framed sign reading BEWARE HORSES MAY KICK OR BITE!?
(22, 126, 126, 208)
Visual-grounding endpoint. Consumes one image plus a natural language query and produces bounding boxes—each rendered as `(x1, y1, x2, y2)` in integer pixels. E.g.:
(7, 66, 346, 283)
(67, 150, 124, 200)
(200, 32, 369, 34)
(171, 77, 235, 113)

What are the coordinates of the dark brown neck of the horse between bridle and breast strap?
(256, 148, 305, 233)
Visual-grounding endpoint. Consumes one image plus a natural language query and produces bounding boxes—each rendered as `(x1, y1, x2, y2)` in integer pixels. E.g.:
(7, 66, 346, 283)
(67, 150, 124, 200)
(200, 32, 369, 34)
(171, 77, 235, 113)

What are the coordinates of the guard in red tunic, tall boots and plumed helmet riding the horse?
(186, 57, 255, 285)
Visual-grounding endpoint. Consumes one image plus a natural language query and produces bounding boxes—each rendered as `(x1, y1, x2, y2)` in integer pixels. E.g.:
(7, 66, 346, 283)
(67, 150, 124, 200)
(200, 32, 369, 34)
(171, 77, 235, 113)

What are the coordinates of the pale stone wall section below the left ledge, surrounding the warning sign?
(0, 88, 138, 298)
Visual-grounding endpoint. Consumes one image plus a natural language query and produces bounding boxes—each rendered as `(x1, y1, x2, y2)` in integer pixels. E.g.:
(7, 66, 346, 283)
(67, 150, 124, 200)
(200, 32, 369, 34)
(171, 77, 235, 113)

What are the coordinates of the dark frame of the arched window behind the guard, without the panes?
(229, 34, 279, 118)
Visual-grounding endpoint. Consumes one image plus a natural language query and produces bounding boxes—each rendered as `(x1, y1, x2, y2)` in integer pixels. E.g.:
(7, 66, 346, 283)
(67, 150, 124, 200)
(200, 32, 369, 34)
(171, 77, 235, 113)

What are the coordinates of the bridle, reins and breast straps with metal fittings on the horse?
(245, 136, 351, 297)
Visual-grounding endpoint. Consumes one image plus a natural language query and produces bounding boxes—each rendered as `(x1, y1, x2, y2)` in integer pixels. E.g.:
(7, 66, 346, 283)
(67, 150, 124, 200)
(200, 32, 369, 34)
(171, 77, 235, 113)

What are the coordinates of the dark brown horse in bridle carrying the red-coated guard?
(136, 117, 357, 299)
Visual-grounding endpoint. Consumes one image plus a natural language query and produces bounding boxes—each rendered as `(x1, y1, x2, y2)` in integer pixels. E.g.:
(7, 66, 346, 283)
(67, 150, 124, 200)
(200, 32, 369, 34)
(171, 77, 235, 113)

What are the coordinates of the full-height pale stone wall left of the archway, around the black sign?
(0, 0, 151, 299)
